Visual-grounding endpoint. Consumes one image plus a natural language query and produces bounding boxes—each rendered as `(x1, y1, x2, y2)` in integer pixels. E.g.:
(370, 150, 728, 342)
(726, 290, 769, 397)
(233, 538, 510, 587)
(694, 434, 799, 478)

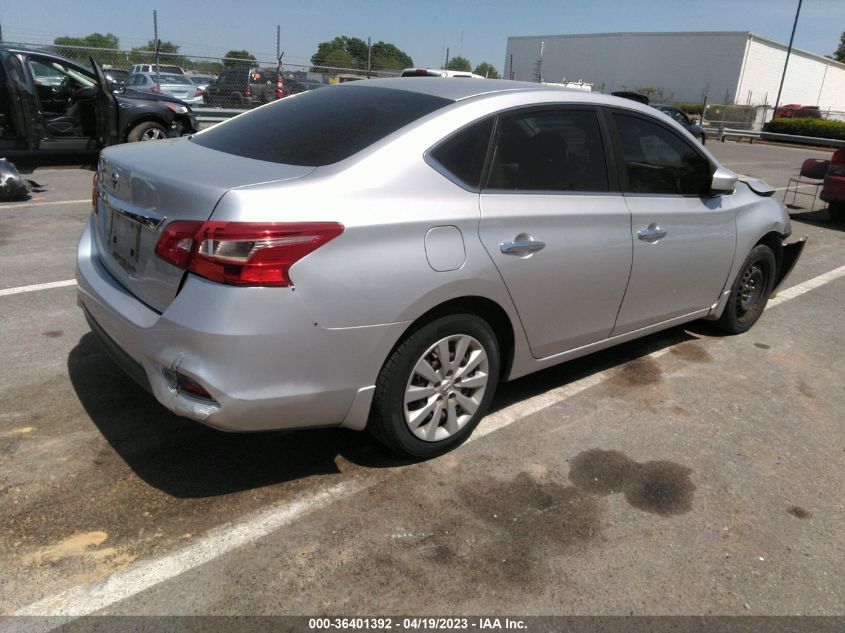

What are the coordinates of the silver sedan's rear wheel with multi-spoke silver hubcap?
(367, 313, 500, 459)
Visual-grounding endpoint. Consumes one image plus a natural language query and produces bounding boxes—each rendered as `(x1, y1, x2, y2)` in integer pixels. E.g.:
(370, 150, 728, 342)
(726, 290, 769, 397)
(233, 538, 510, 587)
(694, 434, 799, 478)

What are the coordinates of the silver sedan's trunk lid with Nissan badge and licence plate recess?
(96, 139, 314, 312)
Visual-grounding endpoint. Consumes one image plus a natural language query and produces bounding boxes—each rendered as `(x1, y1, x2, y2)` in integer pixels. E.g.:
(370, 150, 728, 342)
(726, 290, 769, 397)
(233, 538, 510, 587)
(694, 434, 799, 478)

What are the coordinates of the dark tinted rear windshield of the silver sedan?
(192, 85, 453, 167)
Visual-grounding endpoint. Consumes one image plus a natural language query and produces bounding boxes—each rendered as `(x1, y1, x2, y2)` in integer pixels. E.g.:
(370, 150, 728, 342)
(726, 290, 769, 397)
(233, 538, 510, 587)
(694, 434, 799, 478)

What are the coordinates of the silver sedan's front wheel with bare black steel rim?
(718, 244, 777, 334)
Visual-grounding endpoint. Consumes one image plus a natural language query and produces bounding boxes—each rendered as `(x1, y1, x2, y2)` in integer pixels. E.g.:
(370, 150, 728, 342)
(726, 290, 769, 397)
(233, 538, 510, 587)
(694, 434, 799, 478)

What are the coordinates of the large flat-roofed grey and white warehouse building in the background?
(504, 31, 845, 110)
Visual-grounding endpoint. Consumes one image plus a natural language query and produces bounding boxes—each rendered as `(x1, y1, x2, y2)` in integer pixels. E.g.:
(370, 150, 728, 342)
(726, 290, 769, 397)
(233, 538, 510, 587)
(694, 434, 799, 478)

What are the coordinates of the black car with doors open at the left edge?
(0, 46, 197, 156)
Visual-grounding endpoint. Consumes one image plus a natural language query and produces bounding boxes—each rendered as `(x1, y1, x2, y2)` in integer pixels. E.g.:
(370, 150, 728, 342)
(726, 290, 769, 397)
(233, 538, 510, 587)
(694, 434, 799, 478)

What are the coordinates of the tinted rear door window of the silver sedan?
(488, 109, 608, 191)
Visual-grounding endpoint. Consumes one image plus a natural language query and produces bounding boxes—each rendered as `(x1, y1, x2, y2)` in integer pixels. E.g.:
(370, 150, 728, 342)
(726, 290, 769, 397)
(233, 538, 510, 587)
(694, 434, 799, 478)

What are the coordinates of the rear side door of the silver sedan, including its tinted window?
(480, 106, 631, 358)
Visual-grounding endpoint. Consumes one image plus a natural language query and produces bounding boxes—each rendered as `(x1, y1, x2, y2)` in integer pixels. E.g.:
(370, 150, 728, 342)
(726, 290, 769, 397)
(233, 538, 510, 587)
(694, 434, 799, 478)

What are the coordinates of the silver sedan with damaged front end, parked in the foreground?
(77, 78, 803, 457)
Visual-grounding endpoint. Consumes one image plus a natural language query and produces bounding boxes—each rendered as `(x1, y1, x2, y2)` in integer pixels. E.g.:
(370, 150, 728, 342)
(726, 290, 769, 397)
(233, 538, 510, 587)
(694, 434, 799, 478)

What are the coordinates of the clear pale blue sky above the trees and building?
(0, 0, 845, 72)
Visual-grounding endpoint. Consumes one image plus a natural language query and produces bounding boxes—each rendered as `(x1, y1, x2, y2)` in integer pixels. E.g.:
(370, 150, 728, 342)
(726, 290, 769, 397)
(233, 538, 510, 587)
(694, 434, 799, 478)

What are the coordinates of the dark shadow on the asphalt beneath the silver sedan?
(67, 327, 706, 498)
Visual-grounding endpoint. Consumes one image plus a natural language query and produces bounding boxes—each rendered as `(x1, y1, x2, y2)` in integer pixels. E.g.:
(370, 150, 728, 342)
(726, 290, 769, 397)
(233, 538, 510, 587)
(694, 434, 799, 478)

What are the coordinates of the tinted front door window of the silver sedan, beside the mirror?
(613, 113, 711, 195)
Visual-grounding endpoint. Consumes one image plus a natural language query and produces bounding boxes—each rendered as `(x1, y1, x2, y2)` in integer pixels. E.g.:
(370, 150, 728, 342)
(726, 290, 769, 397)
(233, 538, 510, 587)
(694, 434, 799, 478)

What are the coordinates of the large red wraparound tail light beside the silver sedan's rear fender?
(156, 220, 344, 286)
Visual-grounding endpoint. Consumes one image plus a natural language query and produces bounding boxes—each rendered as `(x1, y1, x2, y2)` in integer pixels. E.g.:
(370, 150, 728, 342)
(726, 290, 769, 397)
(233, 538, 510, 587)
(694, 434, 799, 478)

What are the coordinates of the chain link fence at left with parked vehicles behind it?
(3, 41, 401, 109)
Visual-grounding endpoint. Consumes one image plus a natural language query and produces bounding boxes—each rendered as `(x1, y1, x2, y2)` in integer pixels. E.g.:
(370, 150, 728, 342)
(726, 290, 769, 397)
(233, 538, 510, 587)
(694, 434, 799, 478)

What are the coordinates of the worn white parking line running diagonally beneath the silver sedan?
(14, 266, 845, 626)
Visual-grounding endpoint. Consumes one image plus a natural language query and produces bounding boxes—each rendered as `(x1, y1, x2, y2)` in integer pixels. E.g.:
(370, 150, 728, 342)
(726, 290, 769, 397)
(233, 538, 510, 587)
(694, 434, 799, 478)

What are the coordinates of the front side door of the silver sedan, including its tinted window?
(611, 111, 736, 335)
